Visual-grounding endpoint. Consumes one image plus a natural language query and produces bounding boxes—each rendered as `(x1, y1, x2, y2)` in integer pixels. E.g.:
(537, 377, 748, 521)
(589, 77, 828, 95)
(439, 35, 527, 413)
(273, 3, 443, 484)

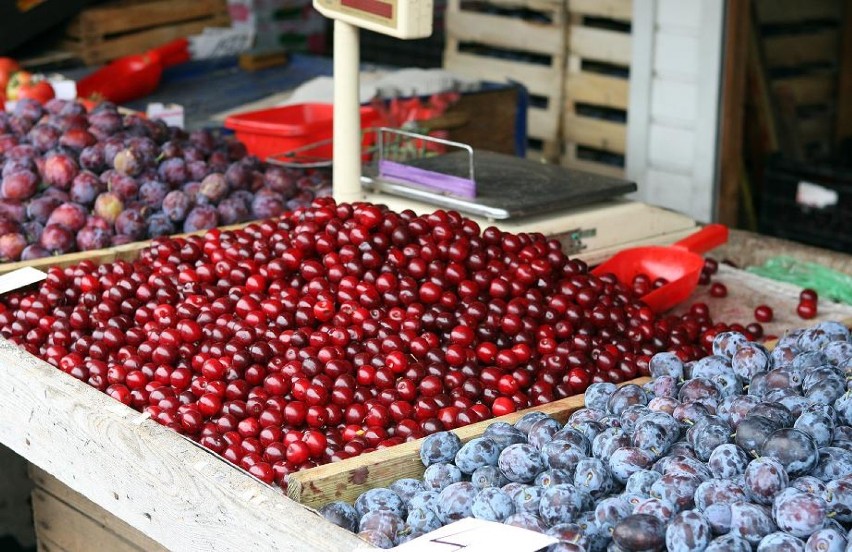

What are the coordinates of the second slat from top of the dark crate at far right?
(763, 29, 840, 69)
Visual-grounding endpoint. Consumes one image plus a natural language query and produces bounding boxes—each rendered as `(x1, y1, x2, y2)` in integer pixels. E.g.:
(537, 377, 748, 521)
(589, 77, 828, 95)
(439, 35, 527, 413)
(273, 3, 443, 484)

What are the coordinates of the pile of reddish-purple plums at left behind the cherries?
(0, 100, 331, 261)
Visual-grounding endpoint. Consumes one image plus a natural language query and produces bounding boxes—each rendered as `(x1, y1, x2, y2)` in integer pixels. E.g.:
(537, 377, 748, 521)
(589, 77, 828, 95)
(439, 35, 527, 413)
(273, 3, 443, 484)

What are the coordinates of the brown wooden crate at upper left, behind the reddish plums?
(64, 0, 230, 65)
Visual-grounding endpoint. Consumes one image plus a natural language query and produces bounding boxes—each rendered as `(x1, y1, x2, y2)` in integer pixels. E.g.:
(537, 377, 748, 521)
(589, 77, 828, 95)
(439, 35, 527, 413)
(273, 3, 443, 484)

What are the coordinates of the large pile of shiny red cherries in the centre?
(0, 198, 740, 486)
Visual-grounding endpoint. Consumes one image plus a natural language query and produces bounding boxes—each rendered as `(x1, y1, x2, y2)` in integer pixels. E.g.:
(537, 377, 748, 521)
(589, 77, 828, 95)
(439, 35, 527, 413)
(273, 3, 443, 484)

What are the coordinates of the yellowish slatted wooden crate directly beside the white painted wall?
(562, 0, 633, 177)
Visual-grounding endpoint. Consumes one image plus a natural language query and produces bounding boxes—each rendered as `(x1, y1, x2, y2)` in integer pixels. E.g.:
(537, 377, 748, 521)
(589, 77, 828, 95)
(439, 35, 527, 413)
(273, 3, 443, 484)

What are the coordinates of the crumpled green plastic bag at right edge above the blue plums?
(746, 256, 852, 305)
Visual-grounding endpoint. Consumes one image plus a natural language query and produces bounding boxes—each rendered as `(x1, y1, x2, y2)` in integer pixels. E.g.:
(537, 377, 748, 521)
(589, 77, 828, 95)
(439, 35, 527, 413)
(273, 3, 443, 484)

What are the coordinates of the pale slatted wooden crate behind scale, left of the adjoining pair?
(444, 0, 566, 160)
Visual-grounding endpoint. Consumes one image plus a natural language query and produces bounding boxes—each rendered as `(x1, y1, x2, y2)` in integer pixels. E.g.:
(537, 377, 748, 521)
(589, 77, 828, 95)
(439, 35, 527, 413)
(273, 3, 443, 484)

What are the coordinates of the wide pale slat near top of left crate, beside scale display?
(445, 10, 565, 55)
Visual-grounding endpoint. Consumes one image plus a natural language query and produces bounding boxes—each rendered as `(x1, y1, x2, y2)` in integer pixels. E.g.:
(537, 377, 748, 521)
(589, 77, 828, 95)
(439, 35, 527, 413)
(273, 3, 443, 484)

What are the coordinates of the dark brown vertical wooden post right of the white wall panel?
(716, 0, 751, 227)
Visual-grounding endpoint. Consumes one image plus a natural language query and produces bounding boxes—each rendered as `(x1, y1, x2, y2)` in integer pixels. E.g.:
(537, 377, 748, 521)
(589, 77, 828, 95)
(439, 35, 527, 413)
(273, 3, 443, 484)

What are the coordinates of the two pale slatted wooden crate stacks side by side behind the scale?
(444, 0, 632, 175)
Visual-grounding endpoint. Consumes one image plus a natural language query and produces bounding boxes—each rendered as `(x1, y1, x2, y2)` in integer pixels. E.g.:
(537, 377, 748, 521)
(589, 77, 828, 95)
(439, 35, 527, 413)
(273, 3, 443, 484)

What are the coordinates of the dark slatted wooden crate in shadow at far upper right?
(754, 0, 844, 160)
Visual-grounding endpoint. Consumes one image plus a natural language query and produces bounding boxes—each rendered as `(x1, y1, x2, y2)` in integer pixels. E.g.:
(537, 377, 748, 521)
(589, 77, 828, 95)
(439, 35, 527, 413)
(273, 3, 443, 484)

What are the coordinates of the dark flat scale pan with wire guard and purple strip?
(362, 128, 637, 220)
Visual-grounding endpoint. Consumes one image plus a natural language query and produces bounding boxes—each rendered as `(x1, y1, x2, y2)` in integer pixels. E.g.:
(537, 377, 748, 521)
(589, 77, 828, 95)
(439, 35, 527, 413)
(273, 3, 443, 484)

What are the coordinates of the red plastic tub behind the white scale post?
(225, 103, 381, 159)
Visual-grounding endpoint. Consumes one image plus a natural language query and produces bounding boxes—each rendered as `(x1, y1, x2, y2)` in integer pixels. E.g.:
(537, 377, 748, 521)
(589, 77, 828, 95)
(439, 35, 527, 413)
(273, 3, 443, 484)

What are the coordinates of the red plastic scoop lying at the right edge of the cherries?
(592, 224, 728, 312)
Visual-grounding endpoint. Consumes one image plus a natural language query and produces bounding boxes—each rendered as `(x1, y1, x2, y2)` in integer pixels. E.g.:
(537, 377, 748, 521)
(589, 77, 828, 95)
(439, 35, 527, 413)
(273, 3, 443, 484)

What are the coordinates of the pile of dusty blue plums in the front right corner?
(320, 322, 852, 552)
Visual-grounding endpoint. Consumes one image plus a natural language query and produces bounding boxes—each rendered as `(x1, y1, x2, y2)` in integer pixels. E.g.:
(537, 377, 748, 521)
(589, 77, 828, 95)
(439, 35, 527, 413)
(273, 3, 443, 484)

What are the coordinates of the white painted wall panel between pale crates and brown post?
(626, 0, 725, 221)
